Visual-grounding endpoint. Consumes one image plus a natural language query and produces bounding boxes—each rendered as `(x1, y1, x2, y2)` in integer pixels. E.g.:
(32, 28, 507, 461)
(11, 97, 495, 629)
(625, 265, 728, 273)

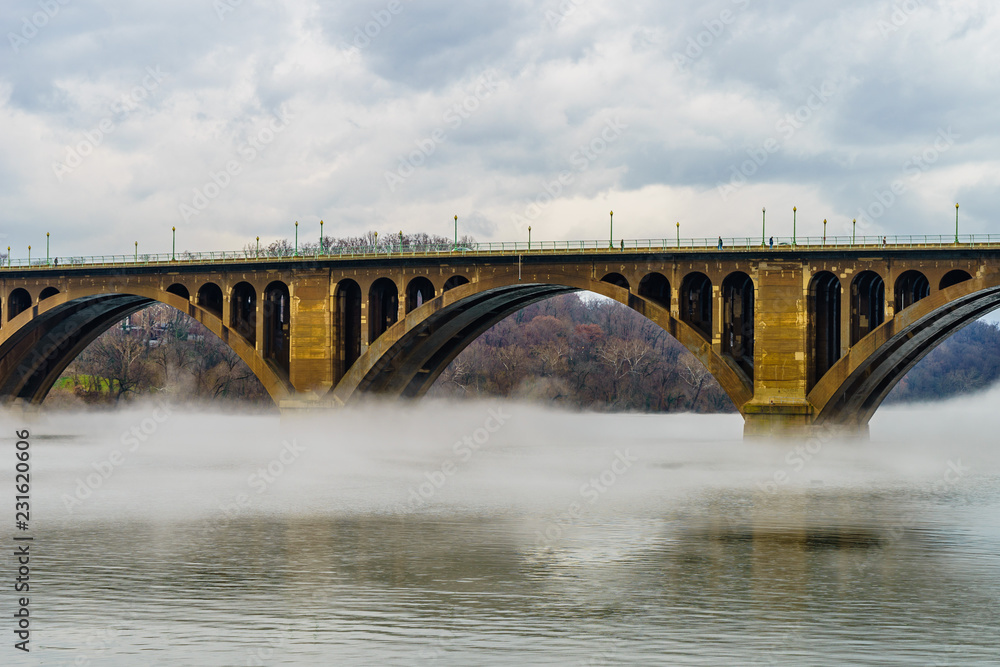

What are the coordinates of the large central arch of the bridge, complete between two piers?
(331, 274, 753, 408)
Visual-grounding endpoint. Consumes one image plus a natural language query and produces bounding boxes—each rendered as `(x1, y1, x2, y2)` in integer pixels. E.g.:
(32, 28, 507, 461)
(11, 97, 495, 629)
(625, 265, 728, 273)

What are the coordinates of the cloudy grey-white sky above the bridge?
(0, 0, 1000, 257)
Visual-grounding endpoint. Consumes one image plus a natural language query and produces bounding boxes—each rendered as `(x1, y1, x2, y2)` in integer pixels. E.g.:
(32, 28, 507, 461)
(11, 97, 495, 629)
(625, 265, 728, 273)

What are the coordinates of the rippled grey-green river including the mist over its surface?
(0, 393, 1000, 666)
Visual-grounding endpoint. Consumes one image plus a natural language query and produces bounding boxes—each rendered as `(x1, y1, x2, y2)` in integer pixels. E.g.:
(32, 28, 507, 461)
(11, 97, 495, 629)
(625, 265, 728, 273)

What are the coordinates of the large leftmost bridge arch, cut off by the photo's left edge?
(0, 283, 294, 404)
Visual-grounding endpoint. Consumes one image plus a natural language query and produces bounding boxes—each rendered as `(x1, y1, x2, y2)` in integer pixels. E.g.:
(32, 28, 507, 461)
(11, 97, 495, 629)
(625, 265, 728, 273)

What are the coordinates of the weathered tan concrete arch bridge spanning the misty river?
(0, 245, 1000, 435)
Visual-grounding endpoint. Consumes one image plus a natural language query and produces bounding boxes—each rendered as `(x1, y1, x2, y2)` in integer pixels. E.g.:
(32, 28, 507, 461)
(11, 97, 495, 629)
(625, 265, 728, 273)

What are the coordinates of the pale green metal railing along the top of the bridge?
(0, 234, 1000, 269)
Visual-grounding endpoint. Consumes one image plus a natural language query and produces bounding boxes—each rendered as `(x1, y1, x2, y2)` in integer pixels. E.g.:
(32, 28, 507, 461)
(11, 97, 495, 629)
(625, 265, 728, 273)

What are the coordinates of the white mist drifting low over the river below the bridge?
(9, 389, 1000, 525)
